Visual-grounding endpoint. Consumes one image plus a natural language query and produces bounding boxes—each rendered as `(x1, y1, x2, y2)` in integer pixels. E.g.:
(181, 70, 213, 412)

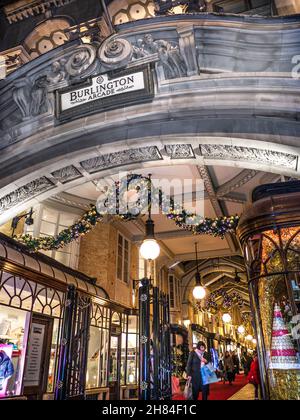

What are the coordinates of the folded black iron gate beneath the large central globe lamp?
(139, 279, 172, 400)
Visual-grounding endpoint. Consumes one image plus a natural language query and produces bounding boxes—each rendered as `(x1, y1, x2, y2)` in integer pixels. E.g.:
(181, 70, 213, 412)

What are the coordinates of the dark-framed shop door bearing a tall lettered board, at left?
(23, 314, 53, 399)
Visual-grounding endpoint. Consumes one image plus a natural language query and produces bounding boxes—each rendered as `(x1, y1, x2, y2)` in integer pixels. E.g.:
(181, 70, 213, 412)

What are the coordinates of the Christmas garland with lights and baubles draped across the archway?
(16, 174, 239, 252)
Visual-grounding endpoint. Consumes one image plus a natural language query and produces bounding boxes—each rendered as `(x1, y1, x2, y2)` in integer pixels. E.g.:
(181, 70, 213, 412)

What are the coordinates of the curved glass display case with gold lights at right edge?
(238, 182, 300, 400)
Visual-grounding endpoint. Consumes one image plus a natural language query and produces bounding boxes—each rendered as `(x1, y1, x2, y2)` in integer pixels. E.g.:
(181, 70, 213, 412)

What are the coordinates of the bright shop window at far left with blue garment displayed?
(0, 306, 30, 398)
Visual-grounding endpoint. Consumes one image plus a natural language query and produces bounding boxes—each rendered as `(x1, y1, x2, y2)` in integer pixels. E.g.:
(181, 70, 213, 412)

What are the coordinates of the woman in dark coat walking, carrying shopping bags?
(186, 341, 211, 401)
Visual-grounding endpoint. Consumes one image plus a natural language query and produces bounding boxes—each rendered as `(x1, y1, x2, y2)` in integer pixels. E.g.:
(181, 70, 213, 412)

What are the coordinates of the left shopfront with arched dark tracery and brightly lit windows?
(0, 235, 138, 399)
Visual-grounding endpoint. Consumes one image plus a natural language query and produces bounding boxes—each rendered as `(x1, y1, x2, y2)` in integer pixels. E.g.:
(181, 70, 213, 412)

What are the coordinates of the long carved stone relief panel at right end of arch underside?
(200, 144, 298, 170)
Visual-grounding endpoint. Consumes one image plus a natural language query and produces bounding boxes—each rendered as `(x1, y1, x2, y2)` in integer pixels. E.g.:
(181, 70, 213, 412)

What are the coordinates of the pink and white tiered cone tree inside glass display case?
(269, 304, 300, 370)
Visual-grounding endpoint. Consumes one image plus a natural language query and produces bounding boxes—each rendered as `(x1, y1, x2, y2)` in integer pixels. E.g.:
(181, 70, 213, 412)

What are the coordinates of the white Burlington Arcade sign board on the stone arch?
(61, 71, 145, 112)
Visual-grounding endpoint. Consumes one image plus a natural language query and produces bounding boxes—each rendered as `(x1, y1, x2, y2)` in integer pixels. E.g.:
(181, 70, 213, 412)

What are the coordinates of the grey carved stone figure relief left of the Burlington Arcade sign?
(13, 76, 50, 120)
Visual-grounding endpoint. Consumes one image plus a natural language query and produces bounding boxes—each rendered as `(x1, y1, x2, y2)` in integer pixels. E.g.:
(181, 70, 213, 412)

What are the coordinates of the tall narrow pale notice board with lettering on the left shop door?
(24, 323, 46, 387)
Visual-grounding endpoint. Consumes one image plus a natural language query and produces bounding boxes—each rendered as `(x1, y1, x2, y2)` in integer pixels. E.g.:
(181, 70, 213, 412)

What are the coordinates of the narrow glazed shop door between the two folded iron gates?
(108, 335, 121, 400)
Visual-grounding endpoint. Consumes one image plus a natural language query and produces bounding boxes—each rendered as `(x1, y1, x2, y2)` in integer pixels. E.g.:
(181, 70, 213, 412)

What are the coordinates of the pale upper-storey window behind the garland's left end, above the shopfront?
(25, 205, 80, 269)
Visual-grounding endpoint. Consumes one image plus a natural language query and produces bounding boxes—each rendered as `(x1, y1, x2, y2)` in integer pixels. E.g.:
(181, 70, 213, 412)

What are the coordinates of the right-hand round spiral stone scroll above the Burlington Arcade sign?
(98, 38, 133, 69)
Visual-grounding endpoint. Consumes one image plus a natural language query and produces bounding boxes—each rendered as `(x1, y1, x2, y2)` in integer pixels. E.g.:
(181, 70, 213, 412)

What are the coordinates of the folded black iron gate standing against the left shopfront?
(55, 286, 91, 400)
